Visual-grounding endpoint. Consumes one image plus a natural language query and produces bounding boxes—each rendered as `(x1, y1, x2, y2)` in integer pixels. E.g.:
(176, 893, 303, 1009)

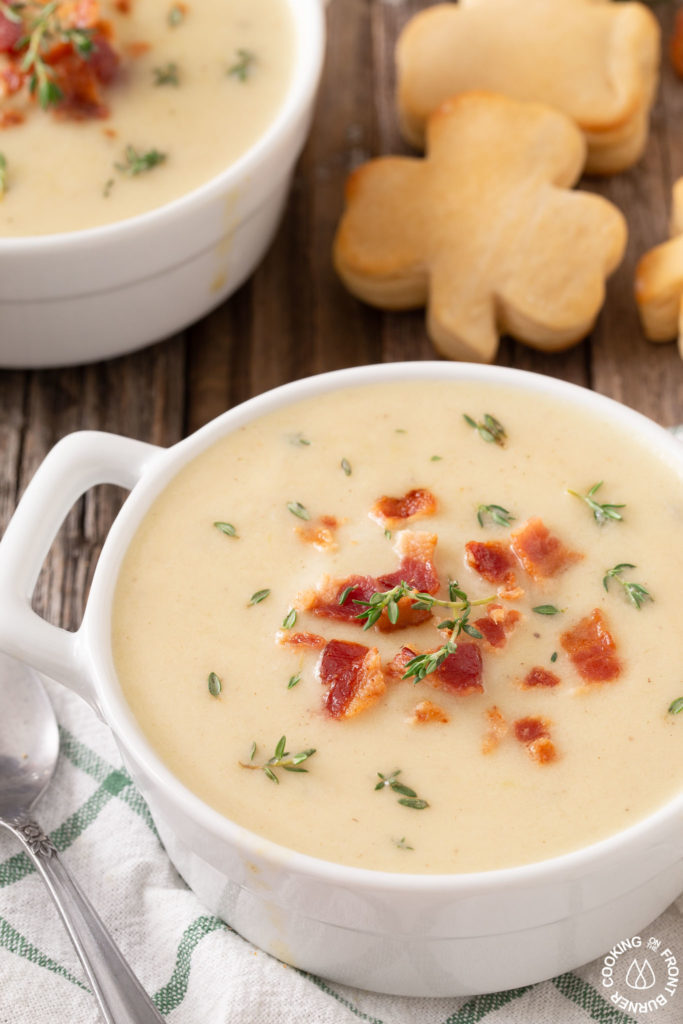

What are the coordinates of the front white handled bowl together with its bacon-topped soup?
(0, 364, 683, 995)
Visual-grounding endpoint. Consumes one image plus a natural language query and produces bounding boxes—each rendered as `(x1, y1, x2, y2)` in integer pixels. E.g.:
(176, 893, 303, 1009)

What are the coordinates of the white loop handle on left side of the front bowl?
(0, 430, 163, 707)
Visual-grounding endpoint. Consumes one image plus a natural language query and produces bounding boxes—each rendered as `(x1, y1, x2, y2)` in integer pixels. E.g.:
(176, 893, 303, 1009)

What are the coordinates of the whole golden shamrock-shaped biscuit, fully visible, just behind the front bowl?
(335, 93, 627, 361)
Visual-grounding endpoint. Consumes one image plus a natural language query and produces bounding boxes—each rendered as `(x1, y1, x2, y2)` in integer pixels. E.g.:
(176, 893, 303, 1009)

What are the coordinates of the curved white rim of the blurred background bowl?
(0, 0, 326, 249)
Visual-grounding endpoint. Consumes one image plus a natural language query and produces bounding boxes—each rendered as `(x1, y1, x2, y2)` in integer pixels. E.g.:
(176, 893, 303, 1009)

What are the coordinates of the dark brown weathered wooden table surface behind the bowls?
(0, 0, 683, 629)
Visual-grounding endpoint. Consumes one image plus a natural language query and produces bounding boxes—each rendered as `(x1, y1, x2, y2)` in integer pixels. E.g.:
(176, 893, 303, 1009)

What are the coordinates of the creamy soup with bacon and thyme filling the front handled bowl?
(113, 382, 683, 872)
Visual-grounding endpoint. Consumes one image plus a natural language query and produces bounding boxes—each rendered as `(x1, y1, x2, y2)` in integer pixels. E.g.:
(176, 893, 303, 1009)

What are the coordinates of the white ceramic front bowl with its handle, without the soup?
(0, 362, 683, 996)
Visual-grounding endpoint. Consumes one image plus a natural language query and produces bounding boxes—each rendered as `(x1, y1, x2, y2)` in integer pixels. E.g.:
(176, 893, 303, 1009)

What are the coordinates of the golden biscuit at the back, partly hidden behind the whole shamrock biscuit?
(396, 0, 659, 174)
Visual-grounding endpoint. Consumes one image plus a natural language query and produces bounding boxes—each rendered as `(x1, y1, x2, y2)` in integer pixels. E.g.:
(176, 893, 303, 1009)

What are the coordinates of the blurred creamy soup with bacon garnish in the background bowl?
(0, 0, 294, 238)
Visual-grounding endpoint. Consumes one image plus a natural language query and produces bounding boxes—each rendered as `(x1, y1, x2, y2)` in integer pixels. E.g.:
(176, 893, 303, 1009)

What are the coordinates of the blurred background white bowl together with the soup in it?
(0, 0, 325, 367)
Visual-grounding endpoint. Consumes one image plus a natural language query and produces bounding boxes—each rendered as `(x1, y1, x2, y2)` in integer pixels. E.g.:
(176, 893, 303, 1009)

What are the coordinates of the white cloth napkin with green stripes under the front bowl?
(0, 671, 683, 1024)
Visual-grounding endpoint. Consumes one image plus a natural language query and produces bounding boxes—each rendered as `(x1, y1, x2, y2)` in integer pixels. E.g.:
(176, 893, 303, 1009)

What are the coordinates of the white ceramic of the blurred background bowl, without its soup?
(0, 0, 325, 367)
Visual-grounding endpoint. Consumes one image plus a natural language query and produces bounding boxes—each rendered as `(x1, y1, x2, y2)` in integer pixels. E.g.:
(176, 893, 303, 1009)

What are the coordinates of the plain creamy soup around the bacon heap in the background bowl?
(0, 0, 294, 237)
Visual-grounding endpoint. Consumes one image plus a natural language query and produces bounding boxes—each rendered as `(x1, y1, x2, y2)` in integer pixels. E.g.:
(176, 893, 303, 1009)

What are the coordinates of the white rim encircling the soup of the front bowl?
(87, 360, 683, 895)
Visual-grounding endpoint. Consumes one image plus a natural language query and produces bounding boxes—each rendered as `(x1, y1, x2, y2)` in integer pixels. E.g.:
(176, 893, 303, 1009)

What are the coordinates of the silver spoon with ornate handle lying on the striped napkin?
(0, 654, 164, 1024)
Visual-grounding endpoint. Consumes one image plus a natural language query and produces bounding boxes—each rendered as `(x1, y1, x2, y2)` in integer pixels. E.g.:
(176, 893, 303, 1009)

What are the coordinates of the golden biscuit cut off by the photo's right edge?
(636, 178, 683, 356)
